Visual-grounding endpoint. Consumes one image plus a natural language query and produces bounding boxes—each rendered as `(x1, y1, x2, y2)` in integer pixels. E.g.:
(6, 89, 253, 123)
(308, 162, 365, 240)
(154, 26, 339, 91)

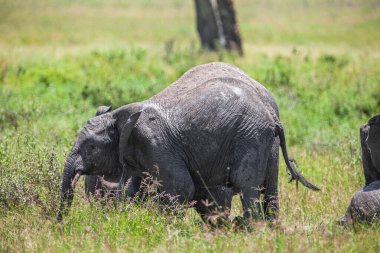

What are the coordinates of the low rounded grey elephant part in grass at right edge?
(341, 180, 380, 225)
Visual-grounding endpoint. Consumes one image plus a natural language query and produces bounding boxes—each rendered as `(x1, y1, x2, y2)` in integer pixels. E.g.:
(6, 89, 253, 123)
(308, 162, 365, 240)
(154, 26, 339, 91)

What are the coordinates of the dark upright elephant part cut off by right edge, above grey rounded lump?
(360, 113, 380, 185)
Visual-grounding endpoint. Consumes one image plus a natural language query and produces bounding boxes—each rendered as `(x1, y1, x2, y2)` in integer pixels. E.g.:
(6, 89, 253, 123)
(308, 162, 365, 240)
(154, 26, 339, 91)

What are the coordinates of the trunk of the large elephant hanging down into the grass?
(57, 155, 82, 221)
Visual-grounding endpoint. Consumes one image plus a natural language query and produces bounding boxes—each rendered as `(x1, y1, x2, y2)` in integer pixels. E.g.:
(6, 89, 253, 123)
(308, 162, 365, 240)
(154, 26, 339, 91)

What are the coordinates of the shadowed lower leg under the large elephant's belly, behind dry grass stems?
(194, 186, 233, 227)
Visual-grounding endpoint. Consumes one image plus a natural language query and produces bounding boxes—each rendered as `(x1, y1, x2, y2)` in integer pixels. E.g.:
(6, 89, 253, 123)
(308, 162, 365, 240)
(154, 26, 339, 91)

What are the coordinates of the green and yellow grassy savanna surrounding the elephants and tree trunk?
(0, 0, 380, 252)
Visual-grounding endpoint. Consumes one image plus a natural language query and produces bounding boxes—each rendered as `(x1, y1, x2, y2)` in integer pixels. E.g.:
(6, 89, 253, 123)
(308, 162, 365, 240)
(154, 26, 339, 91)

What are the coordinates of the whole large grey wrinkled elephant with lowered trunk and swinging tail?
(58, 63, 318, 219)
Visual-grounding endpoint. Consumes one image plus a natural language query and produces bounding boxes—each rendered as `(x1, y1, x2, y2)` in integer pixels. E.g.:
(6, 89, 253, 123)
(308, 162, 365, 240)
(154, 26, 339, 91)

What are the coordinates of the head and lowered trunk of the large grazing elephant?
(57, 106, 141, 220)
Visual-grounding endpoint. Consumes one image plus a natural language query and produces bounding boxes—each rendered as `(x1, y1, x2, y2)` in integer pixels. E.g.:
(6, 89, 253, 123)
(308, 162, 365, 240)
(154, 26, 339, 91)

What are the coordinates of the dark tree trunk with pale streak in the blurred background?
(195, 0, 243, 55)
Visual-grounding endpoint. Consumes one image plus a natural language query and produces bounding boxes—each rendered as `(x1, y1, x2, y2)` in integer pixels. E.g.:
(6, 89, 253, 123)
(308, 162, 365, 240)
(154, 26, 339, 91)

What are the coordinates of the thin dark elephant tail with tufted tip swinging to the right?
(276, 124, 320, 191)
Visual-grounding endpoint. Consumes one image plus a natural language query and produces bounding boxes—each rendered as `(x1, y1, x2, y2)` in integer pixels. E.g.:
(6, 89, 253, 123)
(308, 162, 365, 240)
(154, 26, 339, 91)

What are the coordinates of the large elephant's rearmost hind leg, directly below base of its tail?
(262, 139, 279, 220)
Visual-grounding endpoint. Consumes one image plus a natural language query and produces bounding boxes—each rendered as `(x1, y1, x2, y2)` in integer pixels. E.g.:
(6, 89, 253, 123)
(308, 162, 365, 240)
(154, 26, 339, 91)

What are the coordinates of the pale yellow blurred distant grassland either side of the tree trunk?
(0, 0, 380, 61)
